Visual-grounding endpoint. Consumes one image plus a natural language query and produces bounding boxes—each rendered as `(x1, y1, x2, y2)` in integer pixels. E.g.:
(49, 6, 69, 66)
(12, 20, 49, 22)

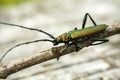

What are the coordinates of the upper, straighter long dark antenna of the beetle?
(0, 22, 55, 39)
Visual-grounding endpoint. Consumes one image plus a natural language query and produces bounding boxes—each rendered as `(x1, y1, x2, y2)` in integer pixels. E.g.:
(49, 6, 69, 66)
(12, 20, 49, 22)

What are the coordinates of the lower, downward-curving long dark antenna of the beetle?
(0, 39, 54, 63)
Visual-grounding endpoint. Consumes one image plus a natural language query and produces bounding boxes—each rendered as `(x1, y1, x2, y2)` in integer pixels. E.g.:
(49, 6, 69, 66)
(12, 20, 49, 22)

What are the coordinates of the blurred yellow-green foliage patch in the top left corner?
(0, 0, 43, 8)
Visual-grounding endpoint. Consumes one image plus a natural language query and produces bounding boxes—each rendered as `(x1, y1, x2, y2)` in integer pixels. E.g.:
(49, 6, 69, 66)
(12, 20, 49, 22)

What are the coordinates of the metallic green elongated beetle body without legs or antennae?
(55, 24, 108, 45)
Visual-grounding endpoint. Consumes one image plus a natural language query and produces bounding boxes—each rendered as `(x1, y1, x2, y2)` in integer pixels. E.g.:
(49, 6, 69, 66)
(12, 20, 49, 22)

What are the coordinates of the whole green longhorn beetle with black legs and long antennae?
(0, 13, 108, 62)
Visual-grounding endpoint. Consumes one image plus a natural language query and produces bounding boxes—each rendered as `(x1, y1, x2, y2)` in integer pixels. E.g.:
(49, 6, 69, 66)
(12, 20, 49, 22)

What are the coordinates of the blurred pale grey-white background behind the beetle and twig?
(0, 0, 120, 80)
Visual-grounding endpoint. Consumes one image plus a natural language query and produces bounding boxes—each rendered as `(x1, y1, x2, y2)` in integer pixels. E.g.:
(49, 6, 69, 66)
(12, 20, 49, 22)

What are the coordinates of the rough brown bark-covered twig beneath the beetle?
(0, 24, 120, 78)
